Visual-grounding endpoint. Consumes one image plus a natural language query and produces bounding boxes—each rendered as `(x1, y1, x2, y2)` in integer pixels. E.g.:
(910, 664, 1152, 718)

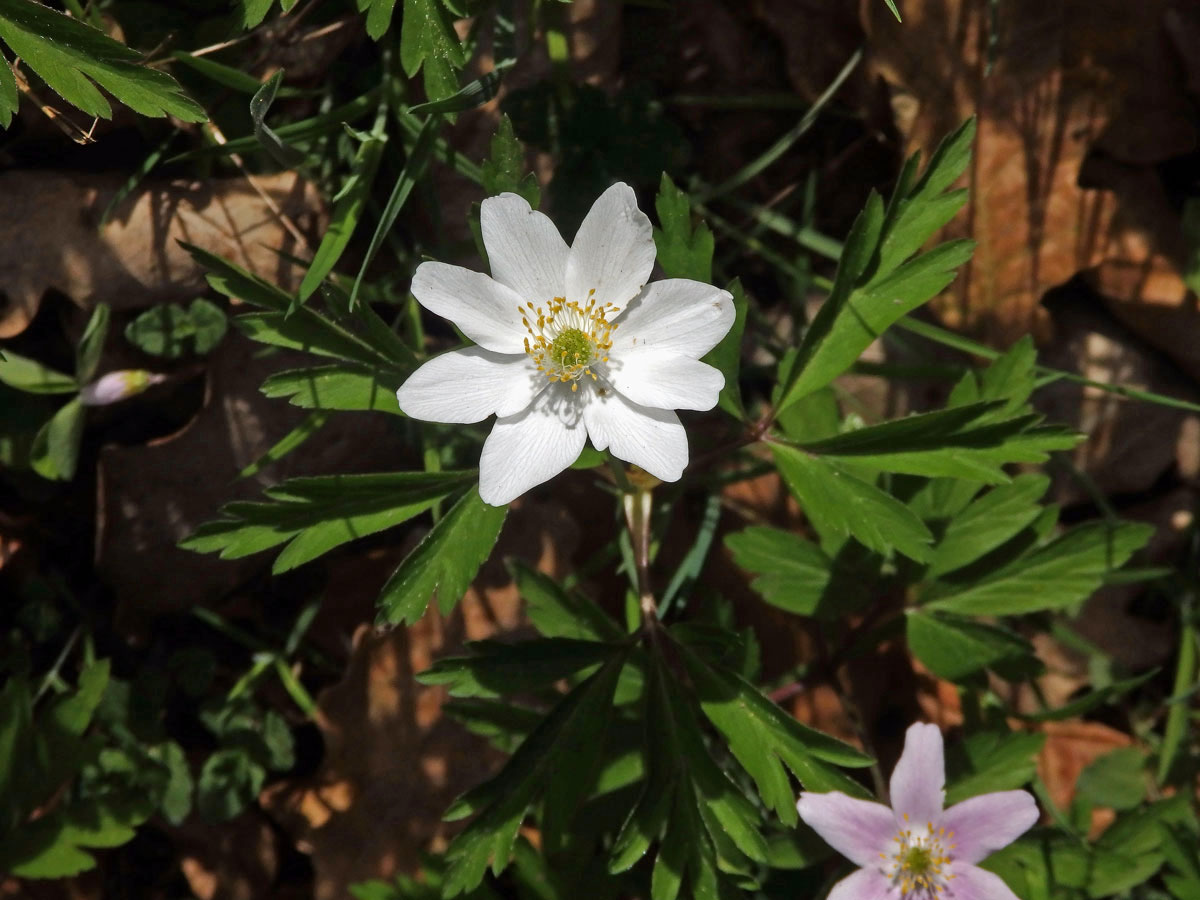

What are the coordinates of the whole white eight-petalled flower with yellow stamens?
(396, 184, 733, 506)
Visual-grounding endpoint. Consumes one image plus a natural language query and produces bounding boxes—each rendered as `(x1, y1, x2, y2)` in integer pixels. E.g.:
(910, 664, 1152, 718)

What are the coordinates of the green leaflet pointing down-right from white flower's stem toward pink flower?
(678, 644, 871, 826)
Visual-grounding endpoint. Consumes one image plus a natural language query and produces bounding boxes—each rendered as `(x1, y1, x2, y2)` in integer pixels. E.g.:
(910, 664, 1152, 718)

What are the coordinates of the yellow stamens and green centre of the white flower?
(517, 290, 617, 391)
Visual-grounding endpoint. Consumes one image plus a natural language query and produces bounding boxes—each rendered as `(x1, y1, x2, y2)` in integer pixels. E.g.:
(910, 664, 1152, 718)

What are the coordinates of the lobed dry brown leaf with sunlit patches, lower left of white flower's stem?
(260, 498, 578, 900)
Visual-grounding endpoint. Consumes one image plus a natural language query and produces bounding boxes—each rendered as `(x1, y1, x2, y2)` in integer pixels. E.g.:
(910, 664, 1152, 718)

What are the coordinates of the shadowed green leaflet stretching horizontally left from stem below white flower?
(416, 637, 614, 697)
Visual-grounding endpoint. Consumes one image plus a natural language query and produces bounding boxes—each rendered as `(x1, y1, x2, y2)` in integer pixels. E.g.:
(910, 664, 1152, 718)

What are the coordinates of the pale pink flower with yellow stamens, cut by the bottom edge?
(797, 724, 1038, 900)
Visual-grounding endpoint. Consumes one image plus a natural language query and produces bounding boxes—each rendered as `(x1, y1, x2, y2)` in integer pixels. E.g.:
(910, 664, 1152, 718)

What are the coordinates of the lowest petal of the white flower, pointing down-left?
(479, 384, 587, 506)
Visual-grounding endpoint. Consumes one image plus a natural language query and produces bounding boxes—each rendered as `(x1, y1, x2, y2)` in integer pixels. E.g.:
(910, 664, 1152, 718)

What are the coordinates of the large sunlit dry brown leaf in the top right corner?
(860, 0, 1196, 341)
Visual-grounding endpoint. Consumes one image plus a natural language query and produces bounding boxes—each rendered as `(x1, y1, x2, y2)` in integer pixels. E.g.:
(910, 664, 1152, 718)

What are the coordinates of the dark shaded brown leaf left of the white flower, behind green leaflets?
(96, 330, 402, 632)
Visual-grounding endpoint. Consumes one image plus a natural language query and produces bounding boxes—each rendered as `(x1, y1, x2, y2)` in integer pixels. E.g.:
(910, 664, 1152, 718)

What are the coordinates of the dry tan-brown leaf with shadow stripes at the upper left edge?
(0, 172, 322, 337)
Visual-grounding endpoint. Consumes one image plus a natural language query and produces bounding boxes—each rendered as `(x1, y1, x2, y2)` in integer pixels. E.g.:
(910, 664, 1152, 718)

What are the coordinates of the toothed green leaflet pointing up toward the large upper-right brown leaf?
(775, 120, 974, 412)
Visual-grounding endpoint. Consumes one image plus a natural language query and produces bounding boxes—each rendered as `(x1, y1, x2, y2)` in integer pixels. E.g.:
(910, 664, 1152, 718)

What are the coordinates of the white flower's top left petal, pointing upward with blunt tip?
(479, 193, 571, 305)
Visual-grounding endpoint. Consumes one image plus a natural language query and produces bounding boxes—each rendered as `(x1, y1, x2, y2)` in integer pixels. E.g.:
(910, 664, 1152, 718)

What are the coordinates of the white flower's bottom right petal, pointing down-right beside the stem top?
(572, 388, 688, 481)
